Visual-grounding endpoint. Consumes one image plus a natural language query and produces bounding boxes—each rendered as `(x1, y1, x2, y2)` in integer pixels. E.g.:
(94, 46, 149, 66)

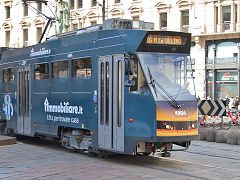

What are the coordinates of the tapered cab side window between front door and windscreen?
(129, 58, 148, 94)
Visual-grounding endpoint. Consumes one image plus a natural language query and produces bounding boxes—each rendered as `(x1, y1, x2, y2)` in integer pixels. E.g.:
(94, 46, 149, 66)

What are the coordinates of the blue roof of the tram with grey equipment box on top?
(0, 19, 191, 63)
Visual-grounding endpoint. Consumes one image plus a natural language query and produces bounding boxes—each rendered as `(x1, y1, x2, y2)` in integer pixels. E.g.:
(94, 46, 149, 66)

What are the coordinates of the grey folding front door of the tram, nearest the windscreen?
(98, 55, 124, 151)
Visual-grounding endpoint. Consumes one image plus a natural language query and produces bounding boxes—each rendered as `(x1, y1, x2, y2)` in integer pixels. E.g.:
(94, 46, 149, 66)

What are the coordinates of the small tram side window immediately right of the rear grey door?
(34, 63, 49, 80)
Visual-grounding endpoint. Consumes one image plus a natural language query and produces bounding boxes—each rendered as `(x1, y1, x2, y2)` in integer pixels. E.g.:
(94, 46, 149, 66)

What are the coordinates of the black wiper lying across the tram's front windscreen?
(148, 67, 181, 109)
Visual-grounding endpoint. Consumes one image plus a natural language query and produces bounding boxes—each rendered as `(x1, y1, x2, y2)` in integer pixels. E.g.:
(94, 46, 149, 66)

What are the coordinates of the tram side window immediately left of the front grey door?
(72, 58, 92, 78)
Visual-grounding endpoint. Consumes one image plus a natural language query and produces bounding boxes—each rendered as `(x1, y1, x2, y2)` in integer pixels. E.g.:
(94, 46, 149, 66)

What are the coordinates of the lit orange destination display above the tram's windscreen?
(147, 35, 187, 46)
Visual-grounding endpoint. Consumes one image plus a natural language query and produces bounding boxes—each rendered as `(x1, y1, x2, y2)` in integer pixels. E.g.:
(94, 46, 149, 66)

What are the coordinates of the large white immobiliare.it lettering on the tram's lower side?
(44, 98, 83, 114)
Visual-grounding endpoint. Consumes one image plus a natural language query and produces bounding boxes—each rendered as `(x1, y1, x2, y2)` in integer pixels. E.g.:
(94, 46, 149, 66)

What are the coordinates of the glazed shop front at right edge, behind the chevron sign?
(206, 39, 239, 99)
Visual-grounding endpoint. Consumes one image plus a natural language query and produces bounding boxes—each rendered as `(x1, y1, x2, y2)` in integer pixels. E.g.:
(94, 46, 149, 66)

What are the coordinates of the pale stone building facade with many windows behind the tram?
(0, 0, 240, 99)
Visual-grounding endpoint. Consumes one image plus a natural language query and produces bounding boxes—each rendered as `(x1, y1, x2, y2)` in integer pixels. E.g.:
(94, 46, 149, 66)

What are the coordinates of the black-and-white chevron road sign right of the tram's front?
(198, 100, 226, 116)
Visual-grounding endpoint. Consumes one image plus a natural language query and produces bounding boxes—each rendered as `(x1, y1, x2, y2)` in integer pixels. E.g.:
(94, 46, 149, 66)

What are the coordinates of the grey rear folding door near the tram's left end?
(17, 67, 31, 134)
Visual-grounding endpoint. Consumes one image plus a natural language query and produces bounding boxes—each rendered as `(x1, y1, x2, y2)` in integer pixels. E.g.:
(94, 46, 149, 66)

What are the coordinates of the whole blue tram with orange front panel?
(0, 19, 198, 156)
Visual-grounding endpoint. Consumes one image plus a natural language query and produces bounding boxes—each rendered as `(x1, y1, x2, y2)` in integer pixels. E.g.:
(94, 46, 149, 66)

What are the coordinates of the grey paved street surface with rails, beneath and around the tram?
(0, 139, 240, 180)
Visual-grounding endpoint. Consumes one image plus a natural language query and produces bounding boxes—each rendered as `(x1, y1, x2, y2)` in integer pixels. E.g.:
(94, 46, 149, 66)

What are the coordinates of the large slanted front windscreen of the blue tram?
(137, 53, 195, 101)
